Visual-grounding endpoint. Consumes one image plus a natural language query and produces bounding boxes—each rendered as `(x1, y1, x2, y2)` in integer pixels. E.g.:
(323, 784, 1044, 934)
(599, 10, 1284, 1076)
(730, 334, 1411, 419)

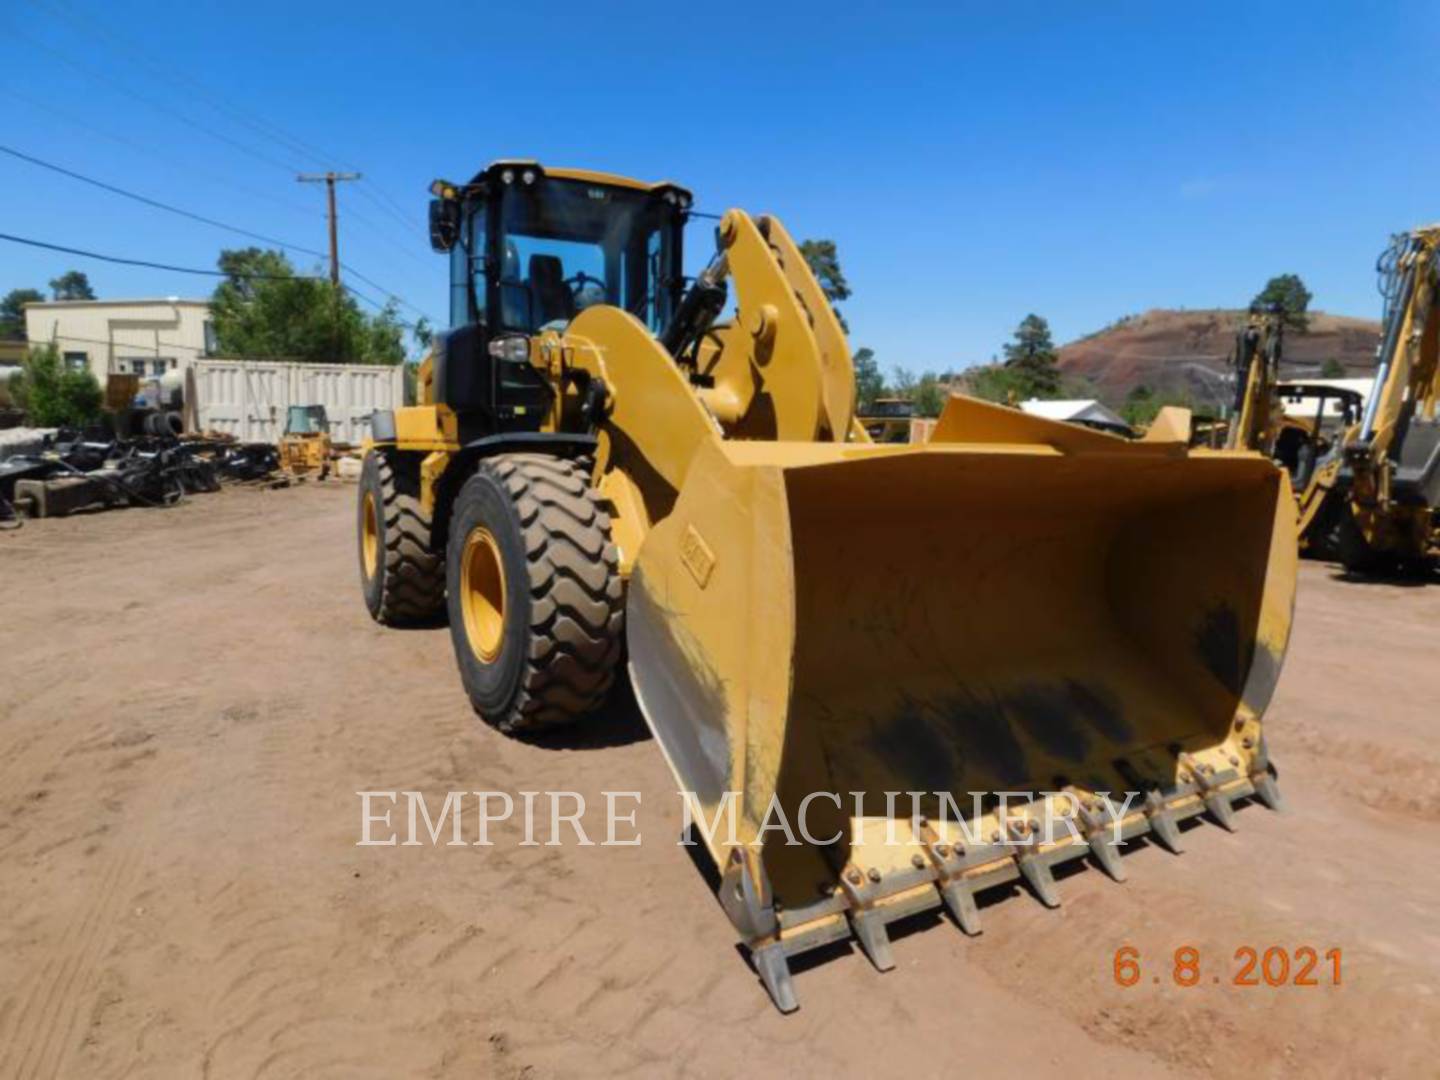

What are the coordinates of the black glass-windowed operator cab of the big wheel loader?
(431, 161, 691, 436)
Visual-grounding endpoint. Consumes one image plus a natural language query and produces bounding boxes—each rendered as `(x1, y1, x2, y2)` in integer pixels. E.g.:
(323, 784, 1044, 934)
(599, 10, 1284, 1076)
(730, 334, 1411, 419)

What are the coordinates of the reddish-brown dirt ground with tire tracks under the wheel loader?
(0, 485, 1440, 1077)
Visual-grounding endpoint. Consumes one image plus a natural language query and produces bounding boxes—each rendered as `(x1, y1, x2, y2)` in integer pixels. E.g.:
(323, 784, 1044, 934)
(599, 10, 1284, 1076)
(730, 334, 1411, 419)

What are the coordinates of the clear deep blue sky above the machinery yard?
(0, 0, 1440, 370)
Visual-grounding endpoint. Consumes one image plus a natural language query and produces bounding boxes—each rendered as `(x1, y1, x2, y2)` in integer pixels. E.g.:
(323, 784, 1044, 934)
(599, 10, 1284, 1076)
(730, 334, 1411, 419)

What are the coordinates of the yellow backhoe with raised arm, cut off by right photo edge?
(1325, 225, 1440, 573)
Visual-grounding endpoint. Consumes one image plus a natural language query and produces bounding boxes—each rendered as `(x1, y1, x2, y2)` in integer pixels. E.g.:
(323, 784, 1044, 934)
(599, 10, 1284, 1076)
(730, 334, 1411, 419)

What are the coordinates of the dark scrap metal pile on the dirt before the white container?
(0, 431, 287, 526)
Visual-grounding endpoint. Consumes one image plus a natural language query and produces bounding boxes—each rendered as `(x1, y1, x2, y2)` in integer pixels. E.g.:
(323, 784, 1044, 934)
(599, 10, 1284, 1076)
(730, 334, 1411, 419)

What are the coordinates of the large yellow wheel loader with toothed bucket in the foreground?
(359, 161, 1296, 1011)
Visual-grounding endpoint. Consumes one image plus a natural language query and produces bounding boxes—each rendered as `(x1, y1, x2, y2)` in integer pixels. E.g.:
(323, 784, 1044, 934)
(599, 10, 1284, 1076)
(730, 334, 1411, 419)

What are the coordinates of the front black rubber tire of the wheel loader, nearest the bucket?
(446, 454, 625, 732)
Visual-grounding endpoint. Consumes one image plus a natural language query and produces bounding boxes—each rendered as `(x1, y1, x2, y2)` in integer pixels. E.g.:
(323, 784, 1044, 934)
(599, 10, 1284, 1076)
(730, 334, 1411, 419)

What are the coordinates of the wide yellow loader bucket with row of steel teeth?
(628, 402, 1296, 1009)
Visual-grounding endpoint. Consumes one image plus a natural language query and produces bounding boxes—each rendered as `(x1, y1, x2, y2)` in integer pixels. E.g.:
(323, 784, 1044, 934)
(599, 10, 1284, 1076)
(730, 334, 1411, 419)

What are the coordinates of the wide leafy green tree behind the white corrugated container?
(210, 248, 405, 364)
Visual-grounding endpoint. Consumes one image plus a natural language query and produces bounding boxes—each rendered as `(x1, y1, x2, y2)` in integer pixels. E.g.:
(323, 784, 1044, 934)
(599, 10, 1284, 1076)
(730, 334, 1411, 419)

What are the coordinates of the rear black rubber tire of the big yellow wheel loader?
(356, 451, 445, 626)
